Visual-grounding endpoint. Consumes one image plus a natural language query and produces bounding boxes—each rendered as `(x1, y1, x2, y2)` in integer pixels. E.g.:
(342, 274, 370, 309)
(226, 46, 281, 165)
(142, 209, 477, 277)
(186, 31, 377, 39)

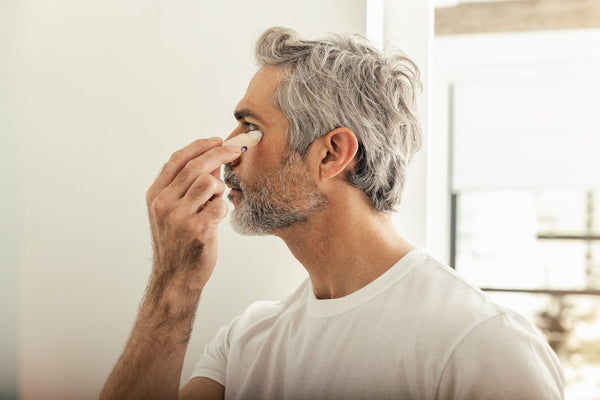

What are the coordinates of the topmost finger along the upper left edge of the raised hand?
(146, 137, 223, 202)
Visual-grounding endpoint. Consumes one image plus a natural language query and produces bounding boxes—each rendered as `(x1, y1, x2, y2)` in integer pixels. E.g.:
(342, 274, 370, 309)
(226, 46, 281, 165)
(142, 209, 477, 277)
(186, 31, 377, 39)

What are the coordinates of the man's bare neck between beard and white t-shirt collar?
(278, 195, 414, 299)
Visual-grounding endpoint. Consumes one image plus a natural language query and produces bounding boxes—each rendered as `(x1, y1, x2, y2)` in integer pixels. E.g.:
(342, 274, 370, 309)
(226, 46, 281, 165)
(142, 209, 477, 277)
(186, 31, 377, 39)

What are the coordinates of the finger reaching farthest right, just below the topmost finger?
(167, 147, 242, 199)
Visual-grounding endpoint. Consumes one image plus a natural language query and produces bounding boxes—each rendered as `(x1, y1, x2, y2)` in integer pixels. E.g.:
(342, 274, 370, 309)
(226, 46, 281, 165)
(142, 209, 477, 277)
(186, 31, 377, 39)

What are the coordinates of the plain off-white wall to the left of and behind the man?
(0, 0, 424, 400)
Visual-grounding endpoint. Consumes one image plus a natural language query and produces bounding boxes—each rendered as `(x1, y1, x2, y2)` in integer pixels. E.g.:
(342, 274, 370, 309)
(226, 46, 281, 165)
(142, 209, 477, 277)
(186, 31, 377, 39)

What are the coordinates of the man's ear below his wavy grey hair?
(319, 127, 358, 178)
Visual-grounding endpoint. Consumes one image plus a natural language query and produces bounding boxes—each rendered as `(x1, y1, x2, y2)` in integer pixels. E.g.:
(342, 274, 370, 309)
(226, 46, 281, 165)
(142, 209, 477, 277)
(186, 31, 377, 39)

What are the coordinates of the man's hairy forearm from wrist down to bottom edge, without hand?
(100, 277, 201, 400)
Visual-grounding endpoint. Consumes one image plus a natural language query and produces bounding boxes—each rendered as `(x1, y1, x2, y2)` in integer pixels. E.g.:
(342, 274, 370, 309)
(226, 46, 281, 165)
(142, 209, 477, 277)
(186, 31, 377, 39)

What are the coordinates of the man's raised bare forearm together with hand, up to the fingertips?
(100, 139, 240, 399)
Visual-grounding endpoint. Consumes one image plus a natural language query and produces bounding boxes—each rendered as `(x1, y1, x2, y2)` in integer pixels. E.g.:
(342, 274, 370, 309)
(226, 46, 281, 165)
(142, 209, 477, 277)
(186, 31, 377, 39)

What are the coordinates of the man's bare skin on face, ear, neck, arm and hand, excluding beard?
(100, 67, 413, 399)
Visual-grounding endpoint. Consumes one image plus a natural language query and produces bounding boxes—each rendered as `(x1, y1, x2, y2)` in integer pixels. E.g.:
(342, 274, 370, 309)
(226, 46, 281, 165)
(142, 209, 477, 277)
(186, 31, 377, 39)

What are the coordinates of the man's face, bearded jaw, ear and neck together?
(221, 68, 412, 299)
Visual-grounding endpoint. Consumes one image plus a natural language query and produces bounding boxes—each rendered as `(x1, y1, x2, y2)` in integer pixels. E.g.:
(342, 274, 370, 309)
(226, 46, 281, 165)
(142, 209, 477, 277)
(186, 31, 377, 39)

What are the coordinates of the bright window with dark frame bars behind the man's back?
(429, 30, 600, 400)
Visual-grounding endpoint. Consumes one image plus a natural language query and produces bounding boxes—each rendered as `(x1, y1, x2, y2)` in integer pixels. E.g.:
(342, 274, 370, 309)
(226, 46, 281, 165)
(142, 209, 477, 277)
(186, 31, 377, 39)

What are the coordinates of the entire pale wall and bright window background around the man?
(0, 0, 600, 399)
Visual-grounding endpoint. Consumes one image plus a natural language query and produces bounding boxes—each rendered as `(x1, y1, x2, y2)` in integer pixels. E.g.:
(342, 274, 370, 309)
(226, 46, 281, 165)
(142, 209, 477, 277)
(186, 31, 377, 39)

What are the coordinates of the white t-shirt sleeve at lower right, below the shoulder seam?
(436, 312, 564, 400)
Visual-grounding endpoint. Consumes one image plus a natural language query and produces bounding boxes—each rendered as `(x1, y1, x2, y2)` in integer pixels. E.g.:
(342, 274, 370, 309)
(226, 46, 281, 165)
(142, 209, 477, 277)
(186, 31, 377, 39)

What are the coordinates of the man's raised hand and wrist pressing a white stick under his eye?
(146, 138, 241, 291)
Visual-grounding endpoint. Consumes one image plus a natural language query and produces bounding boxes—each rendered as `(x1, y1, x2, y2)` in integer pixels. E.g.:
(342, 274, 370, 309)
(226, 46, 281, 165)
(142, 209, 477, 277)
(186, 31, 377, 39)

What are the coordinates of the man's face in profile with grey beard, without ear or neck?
(225, 67, 327, 235)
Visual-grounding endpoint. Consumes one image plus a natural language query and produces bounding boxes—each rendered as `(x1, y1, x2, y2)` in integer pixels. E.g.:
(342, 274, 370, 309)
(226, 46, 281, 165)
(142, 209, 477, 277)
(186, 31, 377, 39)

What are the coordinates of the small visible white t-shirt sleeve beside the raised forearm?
(190, 319, 235, 386)
